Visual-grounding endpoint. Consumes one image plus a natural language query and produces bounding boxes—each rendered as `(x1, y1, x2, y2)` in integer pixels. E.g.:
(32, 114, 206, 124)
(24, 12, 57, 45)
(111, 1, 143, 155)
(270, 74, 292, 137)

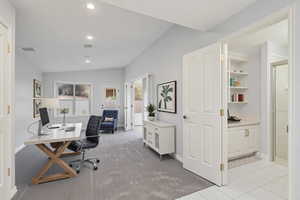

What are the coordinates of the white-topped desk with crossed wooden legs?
(24, 123, 82, 184)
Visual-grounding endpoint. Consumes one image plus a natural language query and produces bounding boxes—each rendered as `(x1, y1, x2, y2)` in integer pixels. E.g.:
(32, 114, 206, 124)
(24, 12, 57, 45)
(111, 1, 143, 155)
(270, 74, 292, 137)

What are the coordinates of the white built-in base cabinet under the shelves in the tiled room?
(228, 125, 260, 160)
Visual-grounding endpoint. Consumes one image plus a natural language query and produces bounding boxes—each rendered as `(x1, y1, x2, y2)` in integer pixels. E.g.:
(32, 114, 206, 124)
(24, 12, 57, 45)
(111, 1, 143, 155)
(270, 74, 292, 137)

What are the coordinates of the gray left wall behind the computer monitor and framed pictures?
(15, 54, 42, 148)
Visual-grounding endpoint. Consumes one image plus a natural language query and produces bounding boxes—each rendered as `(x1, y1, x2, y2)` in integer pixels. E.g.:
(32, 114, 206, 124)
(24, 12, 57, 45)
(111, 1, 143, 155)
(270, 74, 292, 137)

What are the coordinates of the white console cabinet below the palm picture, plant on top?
(143, 121, 175, 158)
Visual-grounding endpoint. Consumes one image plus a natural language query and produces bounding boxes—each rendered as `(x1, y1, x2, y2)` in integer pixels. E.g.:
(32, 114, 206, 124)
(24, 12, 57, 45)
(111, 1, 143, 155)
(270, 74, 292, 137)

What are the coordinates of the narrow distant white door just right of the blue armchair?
(124, 82, 134, 131)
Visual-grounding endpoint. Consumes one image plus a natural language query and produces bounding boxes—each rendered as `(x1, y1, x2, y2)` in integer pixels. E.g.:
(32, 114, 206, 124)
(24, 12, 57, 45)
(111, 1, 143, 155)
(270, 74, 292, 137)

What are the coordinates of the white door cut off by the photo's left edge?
(0, 25, 11, 199)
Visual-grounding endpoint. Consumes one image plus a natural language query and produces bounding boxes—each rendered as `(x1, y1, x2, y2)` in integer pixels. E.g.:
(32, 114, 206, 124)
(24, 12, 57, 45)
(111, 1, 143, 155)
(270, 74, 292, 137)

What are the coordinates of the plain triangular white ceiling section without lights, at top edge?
(98, 0, 256, 31)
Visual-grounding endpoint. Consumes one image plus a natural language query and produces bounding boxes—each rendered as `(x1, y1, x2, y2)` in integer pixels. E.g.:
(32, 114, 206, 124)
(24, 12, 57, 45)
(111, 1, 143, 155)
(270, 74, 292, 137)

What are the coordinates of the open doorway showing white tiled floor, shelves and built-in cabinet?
(222, 16, 290, 200)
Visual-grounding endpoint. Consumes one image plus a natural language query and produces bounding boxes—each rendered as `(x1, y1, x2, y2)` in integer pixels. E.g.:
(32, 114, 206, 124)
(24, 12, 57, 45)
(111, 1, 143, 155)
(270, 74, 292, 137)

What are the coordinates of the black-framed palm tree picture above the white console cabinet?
(157, 81, 177, 113)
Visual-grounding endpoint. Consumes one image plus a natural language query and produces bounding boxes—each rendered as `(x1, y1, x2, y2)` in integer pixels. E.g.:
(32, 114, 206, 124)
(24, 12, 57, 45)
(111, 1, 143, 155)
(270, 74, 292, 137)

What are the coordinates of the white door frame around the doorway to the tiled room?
(221, 3, 297, 200)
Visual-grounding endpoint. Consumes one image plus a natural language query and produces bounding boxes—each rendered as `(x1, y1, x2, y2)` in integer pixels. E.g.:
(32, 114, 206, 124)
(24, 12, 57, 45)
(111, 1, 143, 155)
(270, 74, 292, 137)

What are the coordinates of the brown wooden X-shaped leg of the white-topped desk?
(32, 141, 77, 184)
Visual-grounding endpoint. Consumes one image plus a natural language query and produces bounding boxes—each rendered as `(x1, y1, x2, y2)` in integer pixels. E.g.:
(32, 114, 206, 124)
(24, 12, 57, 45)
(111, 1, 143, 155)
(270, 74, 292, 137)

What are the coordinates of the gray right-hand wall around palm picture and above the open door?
(125, 0, 294, 159)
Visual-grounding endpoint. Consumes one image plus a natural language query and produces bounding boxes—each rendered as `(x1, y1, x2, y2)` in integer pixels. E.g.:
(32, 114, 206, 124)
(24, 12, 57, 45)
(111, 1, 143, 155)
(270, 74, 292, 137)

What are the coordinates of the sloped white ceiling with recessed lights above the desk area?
(11, 0, 172, 72)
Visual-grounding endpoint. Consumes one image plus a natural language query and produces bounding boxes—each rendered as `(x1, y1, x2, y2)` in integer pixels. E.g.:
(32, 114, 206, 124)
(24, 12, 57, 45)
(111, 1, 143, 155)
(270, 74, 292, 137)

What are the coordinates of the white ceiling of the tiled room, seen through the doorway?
(229, 20, 289, 51)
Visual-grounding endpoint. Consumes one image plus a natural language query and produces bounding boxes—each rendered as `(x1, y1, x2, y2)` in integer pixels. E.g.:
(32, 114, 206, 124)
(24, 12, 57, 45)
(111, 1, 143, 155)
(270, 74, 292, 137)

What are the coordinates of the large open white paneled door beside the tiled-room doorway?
(183, 44, 227, 185)
